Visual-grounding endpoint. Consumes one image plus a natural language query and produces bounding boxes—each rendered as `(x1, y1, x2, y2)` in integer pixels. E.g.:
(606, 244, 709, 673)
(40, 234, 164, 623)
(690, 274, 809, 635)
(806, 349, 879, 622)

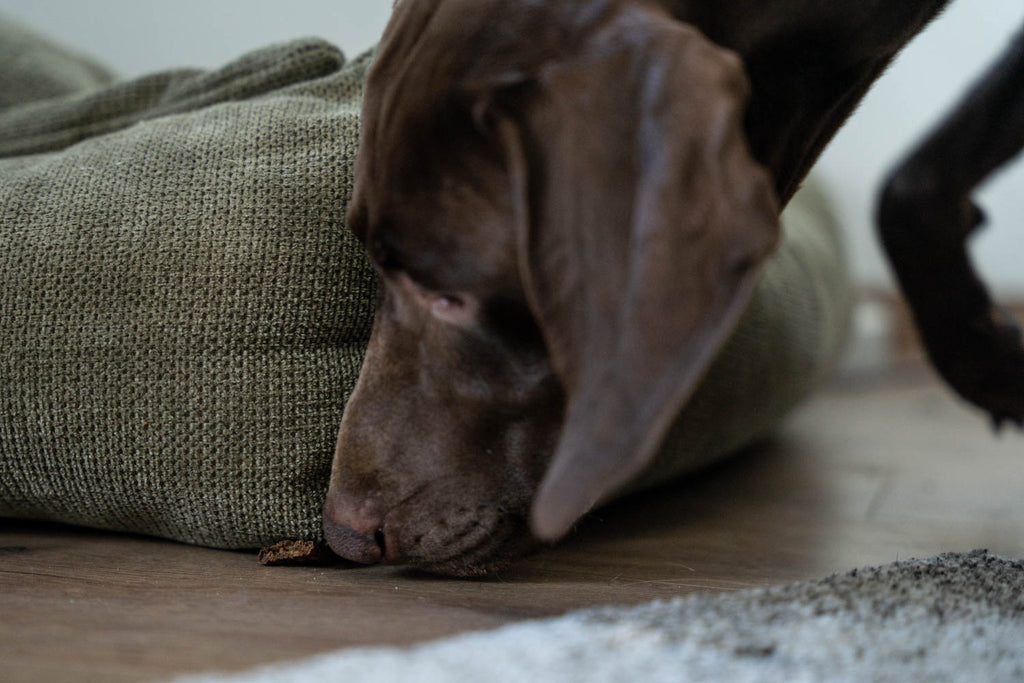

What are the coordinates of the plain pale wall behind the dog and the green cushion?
(0, 0, 1024, 297)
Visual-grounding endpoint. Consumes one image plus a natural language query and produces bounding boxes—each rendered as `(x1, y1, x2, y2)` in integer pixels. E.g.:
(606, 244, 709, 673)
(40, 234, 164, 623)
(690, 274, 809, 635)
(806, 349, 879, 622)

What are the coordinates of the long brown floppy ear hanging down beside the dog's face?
(496, 11, 778, 541)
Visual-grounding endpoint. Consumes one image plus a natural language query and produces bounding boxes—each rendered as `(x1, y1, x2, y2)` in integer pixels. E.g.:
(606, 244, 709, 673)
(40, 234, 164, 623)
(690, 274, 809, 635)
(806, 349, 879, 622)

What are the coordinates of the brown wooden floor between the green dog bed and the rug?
(0, 360, 1024, 683)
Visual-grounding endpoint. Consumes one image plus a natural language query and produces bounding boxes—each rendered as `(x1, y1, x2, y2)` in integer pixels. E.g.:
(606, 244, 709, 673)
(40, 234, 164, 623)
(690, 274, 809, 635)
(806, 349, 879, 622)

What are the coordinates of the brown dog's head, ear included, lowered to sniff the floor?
(325, 0, 777, 574)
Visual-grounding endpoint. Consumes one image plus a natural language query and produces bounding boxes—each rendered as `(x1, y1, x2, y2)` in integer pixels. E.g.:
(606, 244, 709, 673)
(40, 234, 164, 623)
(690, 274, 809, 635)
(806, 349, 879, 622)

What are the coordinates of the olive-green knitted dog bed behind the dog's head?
(0, 17, 849, 548)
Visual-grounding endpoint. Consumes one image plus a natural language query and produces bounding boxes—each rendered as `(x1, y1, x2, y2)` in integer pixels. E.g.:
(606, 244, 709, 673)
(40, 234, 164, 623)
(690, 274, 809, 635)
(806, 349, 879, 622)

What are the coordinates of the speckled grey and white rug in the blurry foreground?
(172, 551, 1024, 683)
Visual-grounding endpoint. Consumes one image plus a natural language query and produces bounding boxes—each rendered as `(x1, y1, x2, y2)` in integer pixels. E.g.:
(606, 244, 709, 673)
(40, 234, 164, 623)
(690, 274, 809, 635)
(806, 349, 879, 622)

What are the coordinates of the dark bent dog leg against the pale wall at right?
(879, 26, 1024, 428)
